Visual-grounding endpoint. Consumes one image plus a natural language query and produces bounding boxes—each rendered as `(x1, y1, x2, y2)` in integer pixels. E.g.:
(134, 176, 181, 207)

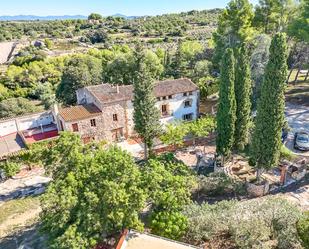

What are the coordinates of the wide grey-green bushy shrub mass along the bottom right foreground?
(184, 197, 300, 249)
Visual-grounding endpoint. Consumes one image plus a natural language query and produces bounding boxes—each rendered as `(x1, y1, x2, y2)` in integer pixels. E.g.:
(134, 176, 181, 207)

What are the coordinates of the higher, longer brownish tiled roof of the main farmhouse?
(86, 78, 198, 103)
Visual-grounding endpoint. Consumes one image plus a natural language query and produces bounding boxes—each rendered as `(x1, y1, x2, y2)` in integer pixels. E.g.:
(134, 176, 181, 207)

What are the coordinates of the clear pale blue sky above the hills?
(0, 0, 257, 16)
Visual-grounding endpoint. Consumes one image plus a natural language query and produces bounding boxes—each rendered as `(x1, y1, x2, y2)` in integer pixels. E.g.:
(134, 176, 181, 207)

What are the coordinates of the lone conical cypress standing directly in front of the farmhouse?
(133, 48, 161, 159)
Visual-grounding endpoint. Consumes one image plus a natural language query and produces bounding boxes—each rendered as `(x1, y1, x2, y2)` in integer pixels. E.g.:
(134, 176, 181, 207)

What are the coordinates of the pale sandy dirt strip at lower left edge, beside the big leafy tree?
(0, 207, 41, 239)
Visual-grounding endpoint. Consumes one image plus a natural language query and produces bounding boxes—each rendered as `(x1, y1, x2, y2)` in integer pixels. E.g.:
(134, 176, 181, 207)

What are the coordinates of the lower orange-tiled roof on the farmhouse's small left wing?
(59, 104, 102, 122)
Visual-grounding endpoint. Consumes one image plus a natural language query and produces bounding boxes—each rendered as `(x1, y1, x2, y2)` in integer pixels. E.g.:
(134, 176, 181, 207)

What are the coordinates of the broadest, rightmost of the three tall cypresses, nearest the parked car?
(251, 33, 287, 180)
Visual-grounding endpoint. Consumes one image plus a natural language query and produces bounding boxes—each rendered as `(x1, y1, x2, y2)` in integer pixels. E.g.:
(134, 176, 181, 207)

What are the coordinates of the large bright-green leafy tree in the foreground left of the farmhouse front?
(41, 134, 146, 248)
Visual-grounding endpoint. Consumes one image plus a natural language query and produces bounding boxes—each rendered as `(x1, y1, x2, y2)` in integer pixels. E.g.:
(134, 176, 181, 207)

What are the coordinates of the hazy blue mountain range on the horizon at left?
(0, 15, 87, 21)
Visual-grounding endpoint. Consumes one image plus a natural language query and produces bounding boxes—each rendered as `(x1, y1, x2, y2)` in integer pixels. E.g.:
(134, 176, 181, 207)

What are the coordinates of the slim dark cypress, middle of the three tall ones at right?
(234, 45, 252, 150)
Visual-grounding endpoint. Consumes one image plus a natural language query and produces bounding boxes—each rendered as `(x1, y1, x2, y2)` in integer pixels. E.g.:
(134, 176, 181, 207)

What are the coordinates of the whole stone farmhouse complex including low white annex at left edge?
(0, 79, 199, 159)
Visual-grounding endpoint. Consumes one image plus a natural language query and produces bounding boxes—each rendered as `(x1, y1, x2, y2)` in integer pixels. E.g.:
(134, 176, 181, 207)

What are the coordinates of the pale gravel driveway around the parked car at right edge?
(285, 103, 309, 157)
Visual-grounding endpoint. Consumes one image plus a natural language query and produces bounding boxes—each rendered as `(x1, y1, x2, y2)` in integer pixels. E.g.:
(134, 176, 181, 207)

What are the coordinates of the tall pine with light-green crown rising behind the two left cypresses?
(213, 0, 254, 68)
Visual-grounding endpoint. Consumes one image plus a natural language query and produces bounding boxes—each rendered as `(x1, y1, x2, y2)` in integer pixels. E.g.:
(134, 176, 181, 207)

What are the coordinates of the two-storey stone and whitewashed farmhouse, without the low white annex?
(55, 78, 199, 143)
